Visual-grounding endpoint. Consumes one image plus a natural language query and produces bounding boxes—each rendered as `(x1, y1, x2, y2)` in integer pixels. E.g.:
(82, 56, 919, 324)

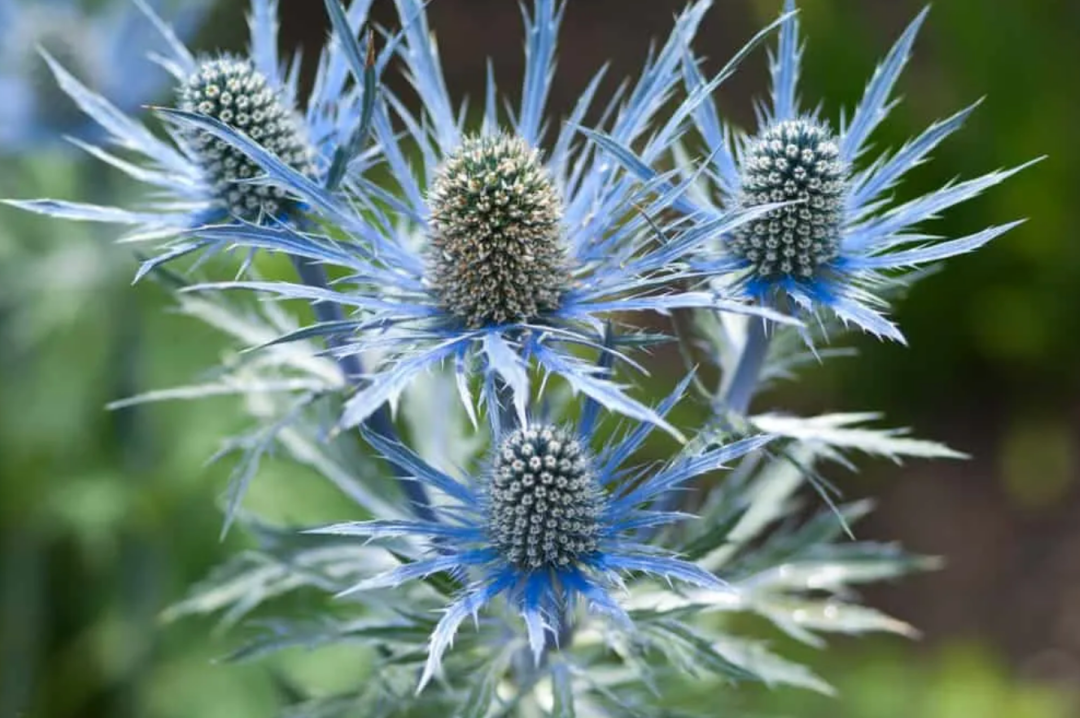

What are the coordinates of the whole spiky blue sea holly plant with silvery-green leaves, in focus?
(4, 0, 1032, 718)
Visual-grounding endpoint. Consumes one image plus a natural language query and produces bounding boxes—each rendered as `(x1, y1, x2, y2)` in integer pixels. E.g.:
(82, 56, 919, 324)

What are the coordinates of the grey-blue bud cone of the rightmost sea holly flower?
(729, 119, 846, 279)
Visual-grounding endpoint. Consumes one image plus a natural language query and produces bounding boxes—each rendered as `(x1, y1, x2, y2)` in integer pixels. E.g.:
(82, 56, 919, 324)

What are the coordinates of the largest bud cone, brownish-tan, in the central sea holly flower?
(429, 136, 568, 327)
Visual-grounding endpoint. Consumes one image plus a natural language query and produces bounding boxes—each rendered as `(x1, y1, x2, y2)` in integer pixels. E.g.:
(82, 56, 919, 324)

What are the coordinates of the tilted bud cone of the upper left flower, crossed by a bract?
(179, 57, 312, 221)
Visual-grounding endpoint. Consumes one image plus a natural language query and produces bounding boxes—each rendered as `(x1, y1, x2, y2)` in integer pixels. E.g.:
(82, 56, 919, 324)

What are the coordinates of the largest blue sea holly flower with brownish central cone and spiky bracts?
(181, 0, 785, 432)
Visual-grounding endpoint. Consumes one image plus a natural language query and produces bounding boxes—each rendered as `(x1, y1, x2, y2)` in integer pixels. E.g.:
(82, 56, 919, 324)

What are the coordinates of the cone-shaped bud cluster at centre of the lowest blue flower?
(488, 426, 603, 570)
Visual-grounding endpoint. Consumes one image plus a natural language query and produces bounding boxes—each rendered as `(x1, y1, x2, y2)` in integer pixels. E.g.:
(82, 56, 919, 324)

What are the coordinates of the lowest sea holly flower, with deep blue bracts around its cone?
(313, 403, 771, 687)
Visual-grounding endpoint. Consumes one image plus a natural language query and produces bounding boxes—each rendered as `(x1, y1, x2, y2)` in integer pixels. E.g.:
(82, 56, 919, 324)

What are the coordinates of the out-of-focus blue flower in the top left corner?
(0, 0, 210, 152)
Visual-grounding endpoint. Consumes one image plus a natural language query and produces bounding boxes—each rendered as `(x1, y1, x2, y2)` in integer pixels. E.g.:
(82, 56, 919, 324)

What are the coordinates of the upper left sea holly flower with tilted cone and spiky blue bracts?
(9, 0, 368, 267)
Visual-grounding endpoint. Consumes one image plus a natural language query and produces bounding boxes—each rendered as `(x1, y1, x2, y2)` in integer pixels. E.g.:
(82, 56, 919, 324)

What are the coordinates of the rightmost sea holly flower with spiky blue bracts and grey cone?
(597, 0, 1027, 341)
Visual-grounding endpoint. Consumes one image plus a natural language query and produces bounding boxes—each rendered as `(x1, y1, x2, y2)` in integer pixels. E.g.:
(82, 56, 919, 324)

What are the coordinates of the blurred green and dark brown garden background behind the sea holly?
(0, 0, 1080, 718)
